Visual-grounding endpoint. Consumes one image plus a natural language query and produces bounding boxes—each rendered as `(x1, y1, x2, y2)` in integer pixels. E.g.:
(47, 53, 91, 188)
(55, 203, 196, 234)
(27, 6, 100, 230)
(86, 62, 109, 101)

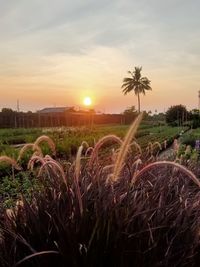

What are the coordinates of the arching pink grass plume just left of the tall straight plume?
(89, 135, 123, 168)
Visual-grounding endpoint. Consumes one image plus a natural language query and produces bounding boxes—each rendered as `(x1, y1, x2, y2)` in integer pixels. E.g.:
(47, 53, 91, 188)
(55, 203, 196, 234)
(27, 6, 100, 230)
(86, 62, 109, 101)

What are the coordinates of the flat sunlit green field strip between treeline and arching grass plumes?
(0, 123, 186, 161)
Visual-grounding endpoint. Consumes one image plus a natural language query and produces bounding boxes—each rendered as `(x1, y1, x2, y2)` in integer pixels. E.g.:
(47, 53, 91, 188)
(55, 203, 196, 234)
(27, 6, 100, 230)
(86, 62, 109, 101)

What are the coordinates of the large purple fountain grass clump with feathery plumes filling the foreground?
(0, 115, 200, 267)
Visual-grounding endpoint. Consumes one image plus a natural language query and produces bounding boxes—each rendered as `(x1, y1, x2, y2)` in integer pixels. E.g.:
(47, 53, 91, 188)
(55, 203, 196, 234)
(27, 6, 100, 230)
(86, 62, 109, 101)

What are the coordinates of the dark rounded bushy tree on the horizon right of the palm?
(166, 105, 189, 126)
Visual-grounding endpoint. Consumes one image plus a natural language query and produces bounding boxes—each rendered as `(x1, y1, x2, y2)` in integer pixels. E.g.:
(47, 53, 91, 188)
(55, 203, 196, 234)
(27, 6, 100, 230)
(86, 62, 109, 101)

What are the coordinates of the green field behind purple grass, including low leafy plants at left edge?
(0, 123, 185, 207)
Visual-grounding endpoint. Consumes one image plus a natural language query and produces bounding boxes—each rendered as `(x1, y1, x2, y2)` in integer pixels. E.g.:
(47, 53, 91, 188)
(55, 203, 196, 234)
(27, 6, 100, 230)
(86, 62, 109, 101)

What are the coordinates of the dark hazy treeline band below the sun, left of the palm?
(0, 108, 135, 128)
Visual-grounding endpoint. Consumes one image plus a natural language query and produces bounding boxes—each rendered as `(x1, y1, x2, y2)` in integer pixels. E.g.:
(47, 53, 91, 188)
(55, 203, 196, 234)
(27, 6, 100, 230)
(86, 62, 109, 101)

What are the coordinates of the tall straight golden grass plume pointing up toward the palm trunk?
(112, 113, 143, 181)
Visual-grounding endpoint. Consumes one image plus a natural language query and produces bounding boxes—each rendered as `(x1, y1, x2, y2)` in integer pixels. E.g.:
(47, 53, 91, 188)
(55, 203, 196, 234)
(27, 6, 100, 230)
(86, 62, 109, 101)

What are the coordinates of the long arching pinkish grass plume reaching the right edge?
(133, 161, 200, 187)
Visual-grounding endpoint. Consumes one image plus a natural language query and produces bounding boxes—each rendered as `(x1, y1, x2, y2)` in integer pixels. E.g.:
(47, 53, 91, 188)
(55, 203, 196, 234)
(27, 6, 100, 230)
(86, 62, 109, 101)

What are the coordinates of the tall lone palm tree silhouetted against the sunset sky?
(122, 67, 152, 113)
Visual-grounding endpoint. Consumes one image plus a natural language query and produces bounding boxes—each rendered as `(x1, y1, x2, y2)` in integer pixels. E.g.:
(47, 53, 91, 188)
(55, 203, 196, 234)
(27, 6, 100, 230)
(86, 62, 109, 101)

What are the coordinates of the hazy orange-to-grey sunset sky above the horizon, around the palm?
(0, 0, 200, 113)
